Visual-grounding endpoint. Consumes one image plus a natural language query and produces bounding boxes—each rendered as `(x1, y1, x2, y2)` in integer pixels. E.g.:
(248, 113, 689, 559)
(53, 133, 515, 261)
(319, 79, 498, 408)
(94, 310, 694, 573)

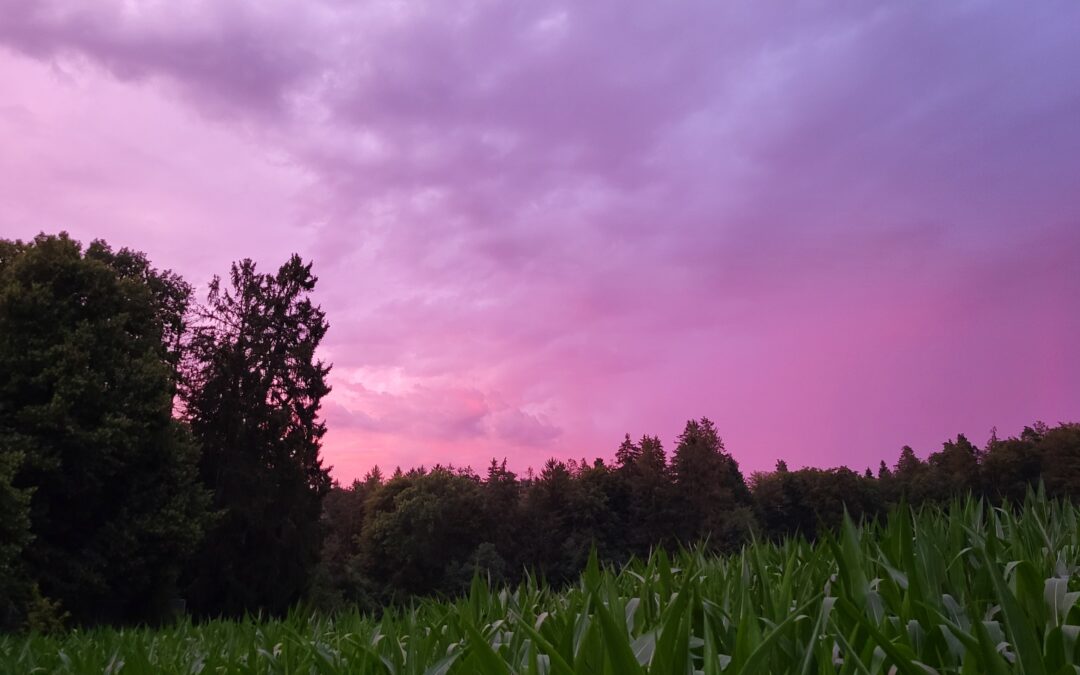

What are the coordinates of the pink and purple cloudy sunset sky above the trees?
(0, 0, 1080, 482)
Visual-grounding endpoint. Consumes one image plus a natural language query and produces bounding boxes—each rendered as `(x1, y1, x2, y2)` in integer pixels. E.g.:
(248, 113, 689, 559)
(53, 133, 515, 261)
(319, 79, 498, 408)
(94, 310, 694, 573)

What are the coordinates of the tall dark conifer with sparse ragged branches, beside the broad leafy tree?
(184, 255, 330, 616)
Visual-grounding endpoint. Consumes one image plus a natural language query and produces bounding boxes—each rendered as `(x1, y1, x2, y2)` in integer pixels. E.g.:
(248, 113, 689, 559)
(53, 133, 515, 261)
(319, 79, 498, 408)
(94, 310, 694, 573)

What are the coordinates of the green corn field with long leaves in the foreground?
(0, 495, 1080, 675)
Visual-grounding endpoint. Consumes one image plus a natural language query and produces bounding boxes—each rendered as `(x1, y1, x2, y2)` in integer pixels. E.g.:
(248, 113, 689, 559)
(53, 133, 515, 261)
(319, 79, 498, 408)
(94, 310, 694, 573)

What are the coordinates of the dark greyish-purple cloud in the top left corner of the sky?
(0, 0, 318, 114)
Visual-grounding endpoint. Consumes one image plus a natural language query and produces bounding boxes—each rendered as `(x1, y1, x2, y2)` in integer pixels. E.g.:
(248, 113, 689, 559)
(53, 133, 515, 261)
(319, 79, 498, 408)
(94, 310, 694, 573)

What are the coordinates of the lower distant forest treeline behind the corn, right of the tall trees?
(311, 419, 1080, 608)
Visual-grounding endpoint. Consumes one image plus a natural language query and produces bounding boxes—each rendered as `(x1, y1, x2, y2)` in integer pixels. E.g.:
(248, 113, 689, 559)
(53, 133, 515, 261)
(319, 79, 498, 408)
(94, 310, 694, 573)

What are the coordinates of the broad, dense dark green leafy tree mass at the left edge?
(0, 234, 206, 623)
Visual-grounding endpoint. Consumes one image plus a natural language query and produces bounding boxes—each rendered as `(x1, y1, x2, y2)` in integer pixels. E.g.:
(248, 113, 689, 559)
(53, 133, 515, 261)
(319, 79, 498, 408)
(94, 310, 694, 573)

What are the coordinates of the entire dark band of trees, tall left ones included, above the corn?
(0, 234, 1080, 630)
